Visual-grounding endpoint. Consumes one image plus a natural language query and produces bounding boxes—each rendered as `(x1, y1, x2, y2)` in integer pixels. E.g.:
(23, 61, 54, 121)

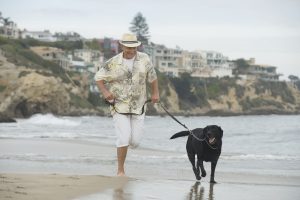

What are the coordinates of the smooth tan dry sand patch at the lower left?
(0, 174, 128, 200)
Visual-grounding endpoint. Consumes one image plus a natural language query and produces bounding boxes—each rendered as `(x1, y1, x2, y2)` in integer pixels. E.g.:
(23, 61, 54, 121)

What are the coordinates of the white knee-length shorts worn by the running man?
(113, 113, 145, 148)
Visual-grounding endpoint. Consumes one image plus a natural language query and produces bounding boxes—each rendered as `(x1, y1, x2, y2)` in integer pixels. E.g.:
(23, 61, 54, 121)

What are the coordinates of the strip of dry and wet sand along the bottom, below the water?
(0, 173, 300, 200)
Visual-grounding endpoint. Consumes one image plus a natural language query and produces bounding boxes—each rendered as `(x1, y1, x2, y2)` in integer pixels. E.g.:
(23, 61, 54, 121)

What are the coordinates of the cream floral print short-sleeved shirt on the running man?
(95, 52, 157, 114)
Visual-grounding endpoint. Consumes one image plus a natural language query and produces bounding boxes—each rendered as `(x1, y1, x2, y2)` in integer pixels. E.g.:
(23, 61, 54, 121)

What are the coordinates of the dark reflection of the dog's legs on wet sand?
(187, 181, 215, 200)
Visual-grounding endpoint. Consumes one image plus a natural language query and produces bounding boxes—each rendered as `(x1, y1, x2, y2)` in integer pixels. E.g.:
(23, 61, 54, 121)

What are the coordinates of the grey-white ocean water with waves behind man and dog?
(0, 114, 300, 176)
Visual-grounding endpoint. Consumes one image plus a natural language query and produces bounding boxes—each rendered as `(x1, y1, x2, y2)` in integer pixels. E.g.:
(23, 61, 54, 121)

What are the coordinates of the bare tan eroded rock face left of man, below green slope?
(0, 47, 104, 117)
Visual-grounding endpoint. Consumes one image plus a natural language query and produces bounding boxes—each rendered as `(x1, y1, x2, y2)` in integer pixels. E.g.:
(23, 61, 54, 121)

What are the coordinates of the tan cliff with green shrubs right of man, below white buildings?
(148, 74, 300, 116)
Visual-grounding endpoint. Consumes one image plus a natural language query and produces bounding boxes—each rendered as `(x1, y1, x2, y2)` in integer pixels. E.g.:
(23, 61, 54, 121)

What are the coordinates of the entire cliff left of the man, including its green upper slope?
(0, 40, 104, 117)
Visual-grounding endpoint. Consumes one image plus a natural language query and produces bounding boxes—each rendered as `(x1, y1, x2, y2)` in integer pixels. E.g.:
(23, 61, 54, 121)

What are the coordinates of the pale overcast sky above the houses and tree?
(0, 0, 300, 80)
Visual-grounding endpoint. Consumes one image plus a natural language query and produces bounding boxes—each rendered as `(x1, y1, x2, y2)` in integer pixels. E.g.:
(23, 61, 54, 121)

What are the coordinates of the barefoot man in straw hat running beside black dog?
(95, 34, 159, 176)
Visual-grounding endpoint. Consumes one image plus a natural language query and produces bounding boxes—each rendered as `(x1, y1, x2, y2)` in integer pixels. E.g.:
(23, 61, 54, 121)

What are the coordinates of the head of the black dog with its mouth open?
(203, 125, 223, 145)
